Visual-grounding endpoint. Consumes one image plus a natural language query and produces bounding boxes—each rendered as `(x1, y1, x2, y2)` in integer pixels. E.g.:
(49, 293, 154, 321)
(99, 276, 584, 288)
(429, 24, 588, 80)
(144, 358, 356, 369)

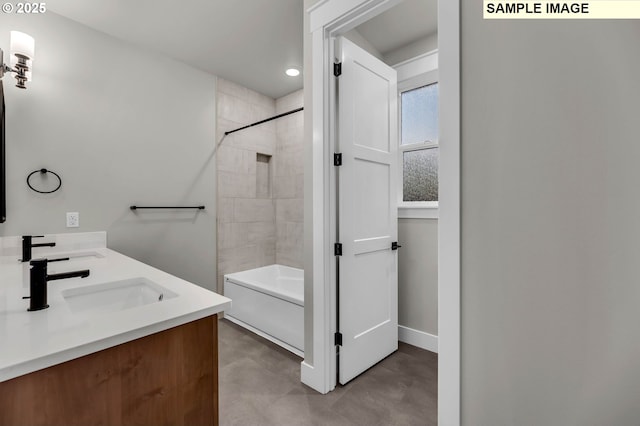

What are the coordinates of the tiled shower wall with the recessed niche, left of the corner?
(216, 78, 276, 292)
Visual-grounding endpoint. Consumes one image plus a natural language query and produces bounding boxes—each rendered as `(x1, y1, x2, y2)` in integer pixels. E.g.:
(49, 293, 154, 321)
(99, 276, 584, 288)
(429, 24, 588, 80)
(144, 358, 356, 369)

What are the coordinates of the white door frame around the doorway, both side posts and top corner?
(301, 0, 460, 426)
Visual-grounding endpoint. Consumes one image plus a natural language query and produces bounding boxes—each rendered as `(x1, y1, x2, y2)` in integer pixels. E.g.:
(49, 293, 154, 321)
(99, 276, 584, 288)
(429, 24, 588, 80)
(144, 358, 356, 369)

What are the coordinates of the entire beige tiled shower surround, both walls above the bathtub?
(216, 79, 303, 292)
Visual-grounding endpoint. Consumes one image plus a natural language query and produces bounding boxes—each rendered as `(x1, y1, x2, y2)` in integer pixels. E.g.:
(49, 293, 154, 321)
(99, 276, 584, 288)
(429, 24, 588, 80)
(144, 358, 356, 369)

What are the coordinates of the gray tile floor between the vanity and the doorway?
(219, 319, 438, 426)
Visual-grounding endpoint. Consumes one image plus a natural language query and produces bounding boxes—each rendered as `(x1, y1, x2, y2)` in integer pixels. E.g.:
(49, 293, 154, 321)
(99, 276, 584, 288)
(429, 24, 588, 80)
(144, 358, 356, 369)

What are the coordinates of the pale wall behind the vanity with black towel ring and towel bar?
(0, 12, 216, 289)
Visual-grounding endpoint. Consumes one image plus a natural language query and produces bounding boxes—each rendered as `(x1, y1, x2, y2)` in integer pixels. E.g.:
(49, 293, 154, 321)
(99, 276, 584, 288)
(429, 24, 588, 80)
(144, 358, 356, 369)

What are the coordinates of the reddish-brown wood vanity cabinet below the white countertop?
(0, 315, 218, 426)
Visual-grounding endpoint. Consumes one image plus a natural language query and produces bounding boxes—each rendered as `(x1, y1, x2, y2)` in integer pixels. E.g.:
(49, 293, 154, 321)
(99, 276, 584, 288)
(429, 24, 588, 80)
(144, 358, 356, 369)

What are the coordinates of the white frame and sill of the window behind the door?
(394, 50, 440, 219)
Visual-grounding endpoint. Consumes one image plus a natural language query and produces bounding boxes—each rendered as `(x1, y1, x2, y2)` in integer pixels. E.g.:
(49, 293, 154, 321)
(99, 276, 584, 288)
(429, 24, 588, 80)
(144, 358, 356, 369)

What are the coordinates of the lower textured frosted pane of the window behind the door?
(402, 148, 439, 201)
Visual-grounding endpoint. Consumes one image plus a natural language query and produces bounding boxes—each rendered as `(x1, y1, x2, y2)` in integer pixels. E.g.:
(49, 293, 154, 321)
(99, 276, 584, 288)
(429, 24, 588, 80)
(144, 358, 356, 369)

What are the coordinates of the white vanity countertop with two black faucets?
(0, 233, 231, 382)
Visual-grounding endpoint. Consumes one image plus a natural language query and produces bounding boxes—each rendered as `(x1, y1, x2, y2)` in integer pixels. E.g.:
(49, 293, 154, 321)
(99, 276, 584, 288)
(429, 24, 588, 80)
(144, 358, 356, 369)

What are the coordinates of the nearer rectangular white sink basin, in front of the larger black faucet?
(62, 277, 178, 314)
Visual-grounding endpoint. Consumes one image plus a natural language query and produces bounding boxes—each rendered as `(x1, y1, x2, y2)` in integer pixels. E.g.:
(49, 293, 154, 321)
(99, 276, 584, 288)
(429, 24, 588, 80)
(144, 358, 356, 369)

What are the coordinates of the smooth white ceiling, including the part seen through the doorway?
(47, 0, 437, 98)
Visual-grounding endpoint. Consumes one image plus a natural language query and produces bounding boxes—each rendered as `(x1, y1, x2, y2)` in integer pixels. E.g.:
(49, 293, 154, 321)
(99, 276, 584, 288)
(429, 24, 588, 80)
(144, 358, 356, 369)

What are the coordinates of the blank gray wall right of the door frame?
(461, 2, 640, 426)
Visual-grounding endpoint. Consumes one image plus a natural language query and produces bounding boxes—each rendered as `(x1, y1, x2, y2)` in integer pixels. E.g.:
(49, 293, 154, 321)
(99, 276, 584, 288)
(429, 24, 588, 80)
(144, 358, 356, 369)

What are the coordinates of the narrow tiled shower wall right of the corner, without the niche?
(274, 90, 304, 269)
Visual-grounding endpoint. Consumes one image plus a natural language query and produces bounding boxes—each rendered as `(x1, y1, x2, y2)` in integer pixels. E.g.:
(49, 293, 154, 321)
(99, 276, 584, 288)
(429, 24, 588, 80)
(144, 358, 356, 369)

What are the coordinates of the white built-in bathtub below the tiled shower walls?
(224, 265, 304, 357)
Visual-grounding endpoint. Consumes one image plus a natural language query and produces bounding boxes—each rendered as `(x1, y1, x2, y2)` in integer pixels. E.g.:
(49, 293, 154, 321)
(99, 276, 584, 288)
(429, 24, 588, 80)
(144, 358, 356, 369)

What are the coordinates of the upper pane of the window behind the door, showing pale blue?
(400, 83, 438, 145)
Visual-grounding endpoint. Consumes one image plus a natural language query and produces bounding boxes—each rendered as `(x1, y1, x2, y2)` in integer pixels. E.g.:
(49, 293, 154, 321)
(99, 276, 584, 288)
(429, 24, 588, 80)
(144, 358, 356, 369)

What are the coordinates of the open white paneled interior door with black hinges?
(337, 38, 398, 384)
